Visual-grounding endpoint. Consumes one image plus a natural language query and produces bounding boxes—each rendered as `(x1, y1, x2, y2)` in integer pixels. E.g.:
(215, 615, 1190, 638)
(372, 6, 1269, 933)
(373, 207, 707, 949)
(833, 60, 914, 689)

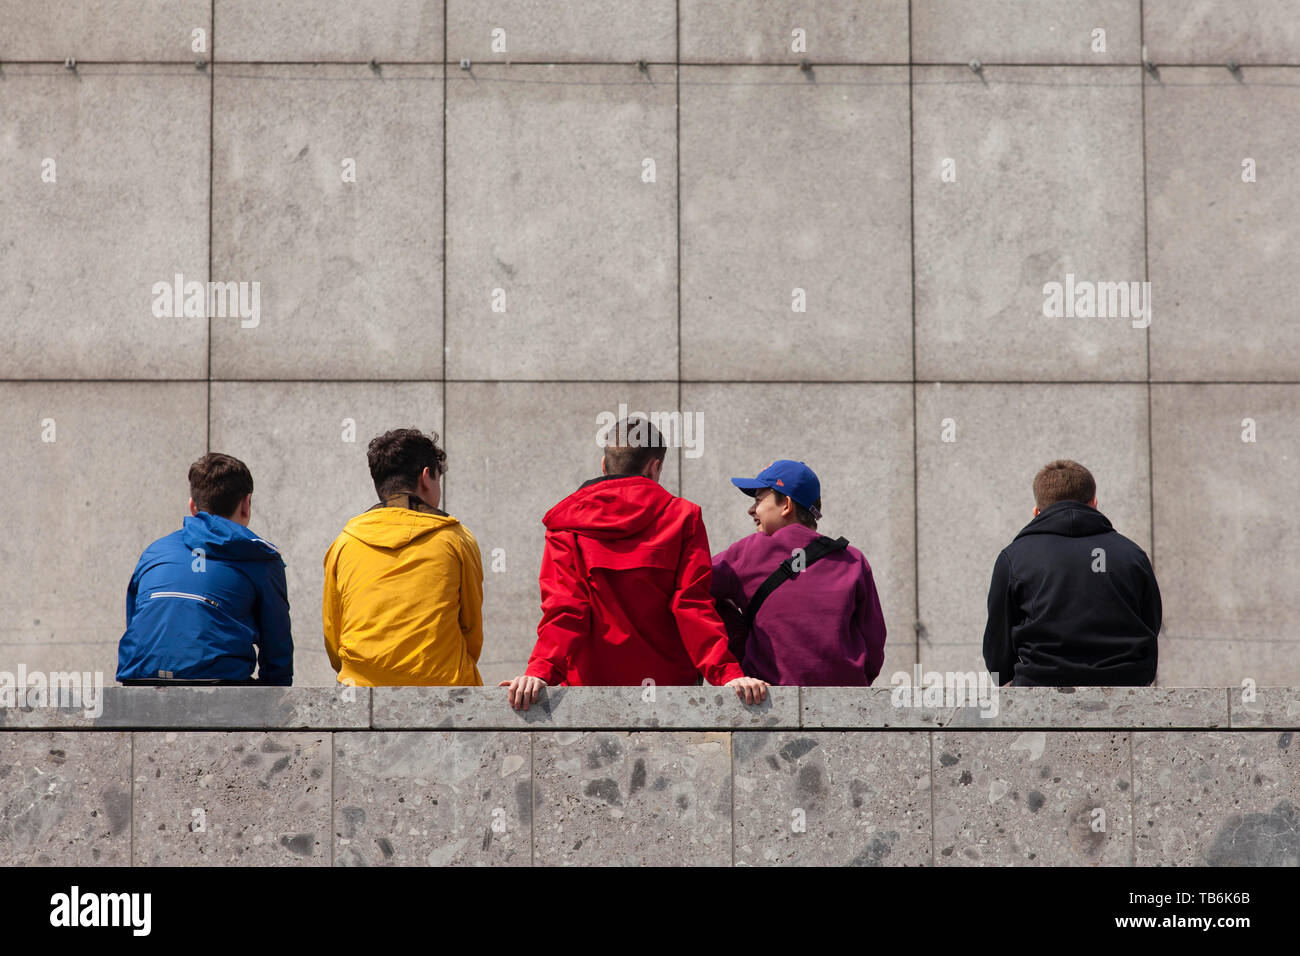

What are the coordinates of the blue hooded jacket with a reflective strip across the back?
(117, 511, 294, 687)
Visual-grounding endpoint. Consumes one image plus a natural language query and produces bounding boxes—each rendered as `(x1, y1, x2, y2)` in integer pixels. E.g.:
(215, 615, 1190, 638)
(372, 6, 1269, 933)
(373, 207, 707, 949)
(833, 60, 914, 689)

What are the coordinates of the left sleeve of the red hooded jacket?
(524, 532, 592, 685)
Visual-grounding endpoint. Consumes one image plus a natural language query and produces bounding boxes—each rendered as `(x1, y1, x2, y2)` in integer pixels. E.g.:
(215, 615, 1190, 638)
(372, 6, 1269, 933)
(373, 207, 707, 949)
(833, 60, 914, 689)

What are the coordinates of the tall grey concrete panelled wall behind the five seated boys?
(0, 0, 1300, 685)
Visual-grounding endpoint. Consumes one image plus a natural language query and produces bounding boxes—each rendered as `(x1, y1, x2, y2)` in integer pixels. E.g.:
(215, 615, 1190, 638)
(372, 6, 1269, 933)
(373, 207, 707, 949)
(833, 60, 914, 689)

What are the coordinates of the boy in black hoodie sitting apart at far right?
(984, 460, 1161, 687)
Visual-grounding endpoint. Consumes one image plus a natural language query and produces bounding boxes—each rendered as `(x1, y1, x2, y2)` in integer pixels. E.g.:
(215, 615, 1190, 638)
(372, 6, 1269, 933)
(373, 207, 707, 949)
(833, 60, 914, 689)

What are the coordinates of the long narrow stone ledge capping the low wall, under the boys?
(0, 685, 1300, 731)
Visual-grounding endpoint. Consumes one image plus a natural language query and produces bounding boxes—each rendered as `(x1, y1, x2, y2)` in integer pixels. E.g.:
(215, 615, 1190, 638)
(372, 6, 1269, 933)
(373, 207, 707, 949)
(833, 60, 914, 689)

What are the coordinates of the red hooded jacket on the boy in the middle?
(527, 475, 745, 685)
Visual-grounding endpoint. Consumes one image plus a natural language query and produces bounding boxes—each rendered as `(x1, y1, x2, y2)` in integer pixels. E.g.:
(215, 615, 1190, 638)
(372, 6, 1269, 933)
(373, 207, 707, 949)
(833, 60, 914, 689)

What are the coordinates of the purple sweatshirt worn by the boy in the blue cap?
(711, 524, 885, 687)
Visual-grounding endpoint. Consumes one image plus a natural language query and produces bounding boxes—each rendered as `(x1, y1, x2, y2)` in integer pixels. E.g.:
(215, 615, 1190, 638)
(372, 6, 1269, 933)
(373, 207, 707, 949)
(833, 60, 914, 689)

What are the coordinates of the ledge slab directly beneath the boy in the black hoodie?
(801, 686, 1229, 730)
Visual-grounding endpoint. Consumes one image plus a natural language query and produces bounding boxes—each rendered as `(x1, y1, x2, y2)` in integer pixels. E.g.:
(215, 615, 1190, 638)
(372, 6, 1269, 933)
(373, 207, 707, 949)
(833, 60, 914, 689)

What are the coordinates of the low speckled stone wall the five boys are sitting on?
(0, 688, 1300, 866)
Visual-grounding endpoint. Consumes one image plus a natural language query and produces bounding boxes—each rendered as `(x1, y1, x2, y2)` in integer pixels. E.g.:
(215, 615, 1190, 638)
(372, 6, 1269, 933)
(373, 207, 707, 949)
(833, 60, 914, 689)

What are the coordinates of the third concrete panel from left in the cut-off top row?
(447, 0, 677, 62)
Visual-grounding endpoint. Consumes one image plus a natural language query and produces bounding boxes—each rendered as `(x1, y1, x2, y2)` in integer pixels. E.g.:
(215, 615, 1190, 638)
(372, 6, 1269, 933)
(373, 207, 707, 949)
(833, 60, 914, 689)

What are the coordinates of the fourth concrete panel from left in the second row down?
(681, 66, 911, 381)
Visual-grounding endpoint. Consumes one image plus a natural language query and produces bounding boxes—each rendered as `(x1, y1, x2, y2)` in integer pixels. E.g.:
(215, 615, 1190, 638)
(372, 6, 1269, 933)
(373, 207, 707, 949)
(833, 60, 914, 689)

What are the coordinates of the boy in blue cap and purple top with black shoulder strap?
(711, 459, 885, 687)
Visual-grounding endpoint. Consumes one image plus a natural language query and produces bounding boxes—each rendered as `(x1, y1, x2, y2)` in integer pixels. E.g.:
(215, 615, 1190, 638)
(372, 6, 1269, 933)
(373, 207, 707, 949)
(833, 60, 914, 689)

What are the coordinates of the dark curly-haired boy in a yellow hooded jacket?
(321, 428, 484, 687)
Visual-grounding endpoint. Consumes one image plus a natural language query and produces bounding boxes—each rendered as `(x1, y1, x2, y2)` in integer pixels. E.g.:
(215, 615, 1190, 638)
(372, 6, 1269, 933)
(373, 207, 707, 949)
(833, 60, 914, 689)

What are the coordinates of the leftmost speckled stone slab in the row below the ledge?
(0, 732, 131, 866)
